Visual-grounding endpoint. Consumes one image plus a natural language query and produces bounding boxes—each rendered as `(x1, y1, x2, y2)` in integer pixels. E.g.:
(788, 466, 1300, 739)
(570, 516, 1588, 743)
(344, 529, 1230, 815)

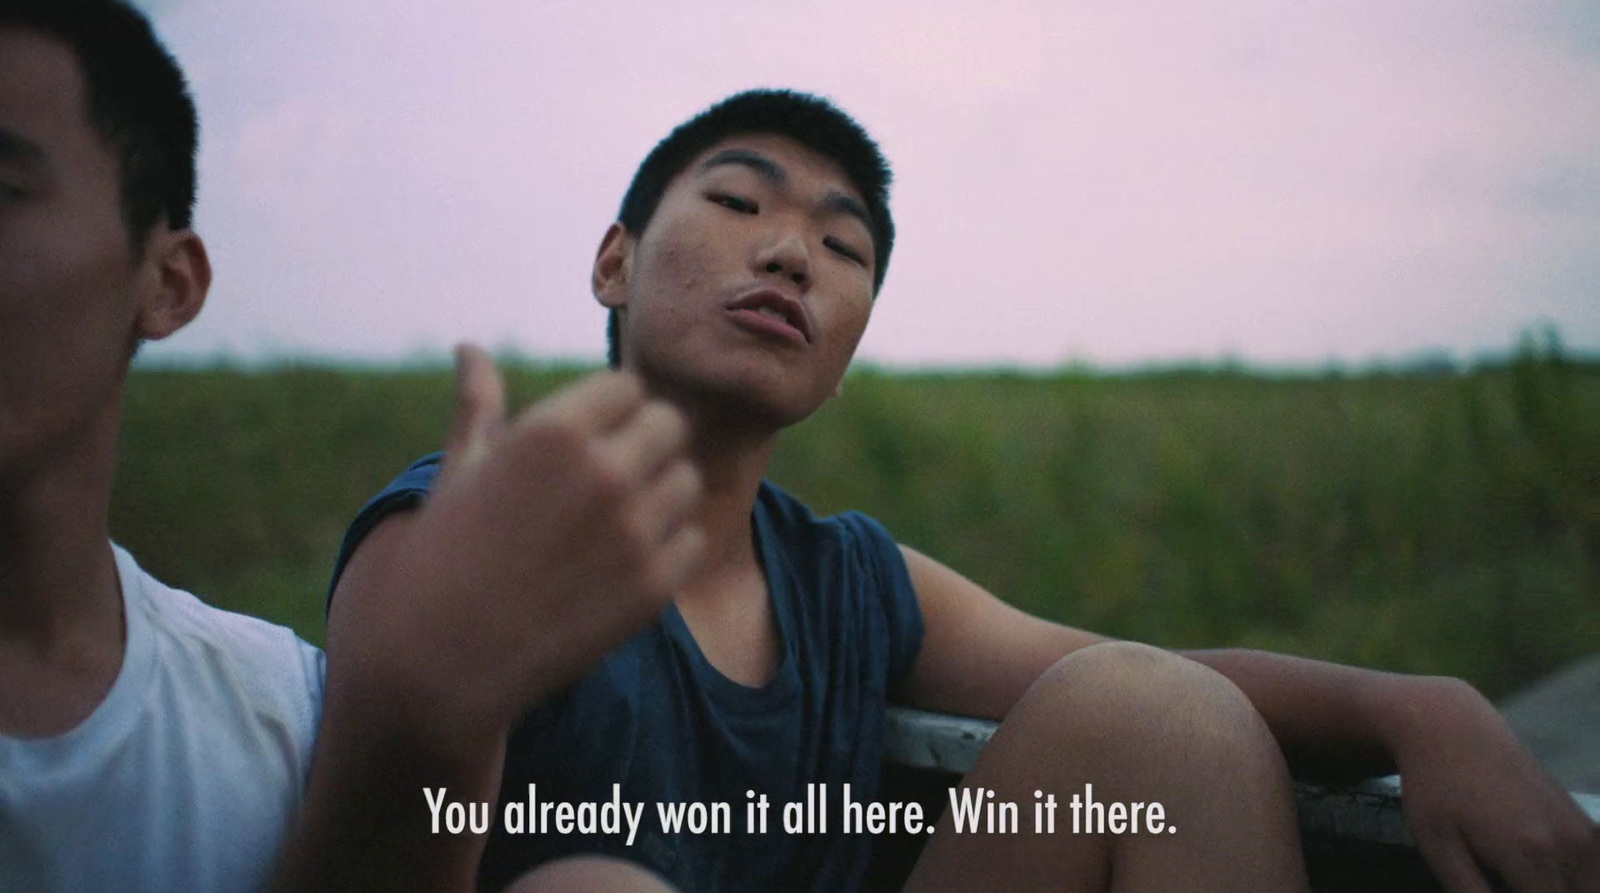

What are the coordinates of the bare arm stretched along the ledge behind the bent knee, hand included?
(902, 547, 1600, 893)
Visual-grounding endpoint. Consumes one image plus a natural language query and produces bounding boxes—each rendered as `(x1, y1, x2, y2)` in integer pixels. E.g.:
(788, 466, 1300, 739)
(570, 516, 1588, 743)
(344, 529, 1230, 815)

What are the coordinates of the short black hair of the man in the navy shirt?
(606, 90, 894, 368)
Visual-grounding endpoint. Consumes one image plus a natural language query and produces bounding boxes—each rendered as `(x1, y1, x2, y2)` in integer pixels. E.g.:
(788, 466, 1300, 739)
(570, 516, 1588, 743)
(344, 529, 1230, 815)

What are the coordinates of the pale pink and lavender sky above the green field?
(134, 0, 1600, 366)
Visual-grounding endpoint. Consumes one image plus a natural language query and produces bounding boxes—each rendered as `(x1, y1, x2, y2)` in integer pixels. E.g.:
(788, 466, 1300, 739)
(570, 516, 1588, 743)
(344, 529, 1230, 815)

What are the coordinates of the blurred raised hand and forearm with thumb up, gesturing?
(272, 349, 704, 893)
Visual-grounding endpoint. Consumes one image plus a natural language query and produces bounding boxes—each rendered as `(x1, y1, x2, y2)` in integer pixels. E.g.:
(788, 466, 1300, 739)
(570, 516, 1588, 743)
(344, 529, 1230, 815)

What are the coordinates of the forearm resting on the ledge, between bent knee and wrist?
(1182, 648, 1466, 781)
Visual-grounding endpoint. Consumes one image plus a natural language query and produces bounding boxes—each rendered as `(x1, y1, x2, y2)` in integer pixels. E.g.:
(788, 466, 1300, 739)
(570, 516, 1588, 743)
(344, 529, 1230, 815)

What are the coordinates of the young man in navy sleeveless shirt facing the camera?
(330, 90, 1600, 893)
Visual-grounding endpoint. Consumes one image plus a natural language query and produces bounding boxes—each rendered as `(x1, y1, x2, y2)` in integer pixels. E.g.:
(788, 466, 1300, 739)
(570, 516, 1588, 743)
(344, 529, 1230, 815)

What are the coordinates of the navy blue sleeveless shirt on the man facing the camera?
(330, 453, 922, 893)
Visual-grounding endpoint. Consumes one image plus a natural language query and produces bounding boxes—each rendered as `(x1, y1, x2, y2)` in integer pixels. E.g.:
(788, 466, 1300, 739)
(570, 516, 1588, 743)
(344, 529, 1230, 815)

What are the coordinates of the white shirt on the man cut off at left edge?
(0, 547, 323, 893)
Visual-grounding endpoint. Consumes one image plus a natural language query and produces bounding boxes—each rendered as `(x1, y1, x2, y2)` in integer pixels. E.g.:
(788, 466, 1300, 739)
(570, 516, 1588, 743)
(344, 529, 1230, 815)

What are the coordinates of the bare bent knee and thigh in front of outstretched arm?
(906, 642, 1307, 893)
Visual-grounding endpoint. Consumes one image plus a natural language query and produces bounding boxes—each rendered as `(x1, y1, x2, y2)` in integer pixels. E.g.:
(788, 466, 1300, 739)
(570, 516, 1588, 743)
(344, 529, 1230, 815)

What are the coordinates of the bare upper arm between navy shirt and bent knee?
(901, 546, 1106, 719)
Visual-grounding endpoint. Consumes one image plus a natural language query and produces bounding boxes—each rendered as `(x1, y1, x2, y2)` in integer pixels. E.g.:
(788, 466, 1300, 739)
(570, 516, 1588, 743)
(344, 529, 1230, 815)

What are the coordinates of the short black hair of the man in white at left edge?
(0, 0, 200, 253)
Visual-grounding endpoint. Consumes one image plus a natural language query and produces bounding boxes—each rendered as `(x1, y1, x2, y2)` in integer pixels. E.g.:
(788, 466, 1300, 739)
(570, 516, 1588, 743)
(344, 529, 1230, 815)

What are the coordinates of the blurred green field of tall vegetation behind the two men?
(112, 336, 1600, 698)
